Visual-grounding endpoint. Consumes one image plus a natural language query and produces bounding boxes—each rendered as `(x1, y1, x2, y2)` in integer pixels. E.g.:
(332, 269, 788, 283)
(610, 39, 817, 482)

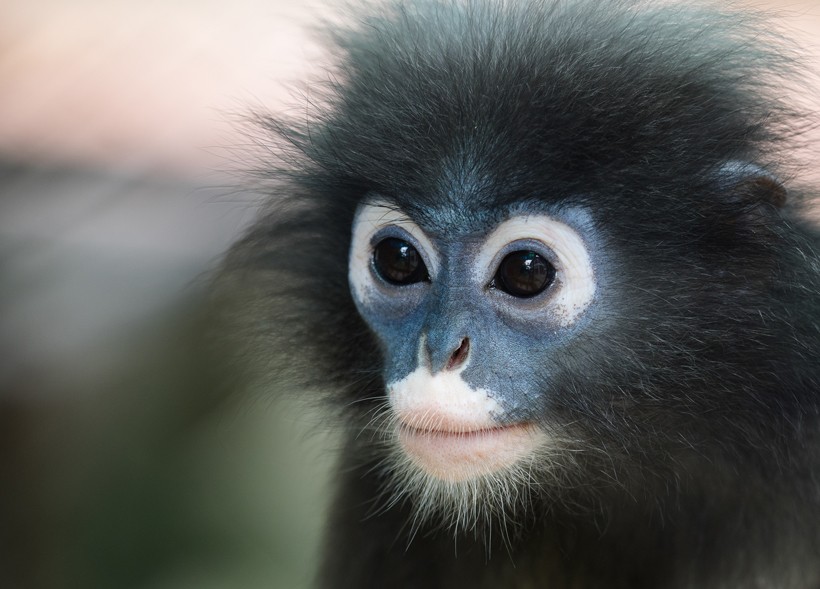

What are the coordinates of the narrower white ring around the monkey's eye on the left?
(348, 200, 439, 302)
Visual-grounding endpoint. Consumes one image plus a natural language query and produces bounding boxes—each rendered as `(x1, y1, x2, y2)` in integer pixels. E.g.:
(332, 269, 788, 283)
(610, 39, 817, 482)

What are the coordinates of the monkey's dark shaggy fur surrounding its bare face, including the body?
(213, 0, 820, 589)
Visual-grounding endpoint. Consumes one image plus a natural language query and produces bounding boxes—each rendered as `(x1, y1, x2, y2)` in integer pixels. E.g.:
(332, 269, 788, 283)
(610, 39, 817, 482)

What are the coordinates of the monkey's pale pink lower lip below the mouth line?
(398, 422, 544, 482)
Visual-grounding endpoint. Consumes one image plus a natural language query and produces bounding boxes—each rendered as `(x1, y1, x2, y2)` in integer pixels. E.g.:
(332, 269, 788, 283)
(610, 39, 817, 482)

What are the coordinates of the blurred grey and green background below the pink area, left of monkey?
(0, 166, 332, 589)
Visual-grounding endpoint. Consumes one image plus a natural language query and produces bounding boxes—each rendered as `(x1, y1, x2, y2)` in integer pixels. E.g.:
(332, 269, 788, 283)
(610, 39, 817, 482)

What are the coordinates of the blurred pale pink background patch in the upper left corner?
(0, 0, 330, 173)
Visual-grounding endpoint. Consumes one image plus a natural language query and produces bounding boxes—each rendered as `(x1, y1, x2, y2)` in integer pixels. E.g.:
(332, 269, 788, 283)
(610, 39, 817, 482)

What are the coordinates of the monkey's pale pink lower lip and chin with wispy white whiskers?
(379, 420, 563, 538)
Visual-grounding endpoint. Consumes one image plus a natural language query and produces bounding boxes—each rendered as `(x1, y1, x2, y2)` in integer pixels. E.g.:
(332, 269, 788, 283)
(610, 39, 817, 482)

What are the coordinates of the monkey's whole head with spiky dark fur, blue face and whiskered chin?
(218, 0, 820, 544)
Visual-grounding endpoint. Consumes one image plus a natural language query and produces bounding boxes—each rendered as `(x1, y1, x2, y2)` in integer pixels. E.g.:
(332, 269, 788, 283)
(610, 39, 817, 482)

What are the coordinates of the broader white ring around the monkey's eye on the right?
(475, 215, 596, 327)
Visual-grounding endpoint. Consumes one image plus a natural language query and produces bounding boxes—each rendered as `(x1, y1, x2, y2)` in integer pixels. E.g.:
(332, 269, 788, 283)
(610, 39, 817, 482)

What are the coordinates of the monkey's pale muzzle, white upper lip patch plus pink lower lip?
(388, 367, 547, 482)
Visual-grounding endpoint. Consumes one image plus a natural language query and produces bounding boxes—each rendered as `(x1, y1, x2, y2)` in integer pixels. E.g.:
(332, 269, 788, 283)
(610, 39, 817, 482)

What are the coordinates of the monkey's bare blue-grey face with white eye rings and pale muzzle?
(349, 200, 599, 482)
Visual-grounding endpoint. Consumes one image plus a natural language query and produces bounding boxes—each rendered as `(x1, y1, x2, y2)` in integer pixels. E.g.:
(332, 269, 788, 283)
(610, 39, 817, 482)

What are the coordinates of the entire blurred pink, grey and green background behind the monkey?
(0, 0, 820, 589)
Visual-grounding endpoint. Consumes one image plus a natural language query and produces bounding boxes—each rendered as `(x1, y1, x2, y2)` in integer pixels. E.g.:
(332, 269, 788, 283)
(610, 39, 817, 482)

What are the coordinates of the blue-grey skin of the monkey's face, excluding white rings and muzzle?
(354, 201, 603, 424)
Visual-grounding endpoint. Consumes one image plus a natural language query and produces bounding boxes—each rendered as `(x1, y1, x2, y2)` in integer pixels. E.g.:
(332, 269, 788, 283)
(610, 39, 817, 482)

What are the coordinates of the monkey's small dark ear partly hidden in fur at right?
(717, 160, 788, 209)
